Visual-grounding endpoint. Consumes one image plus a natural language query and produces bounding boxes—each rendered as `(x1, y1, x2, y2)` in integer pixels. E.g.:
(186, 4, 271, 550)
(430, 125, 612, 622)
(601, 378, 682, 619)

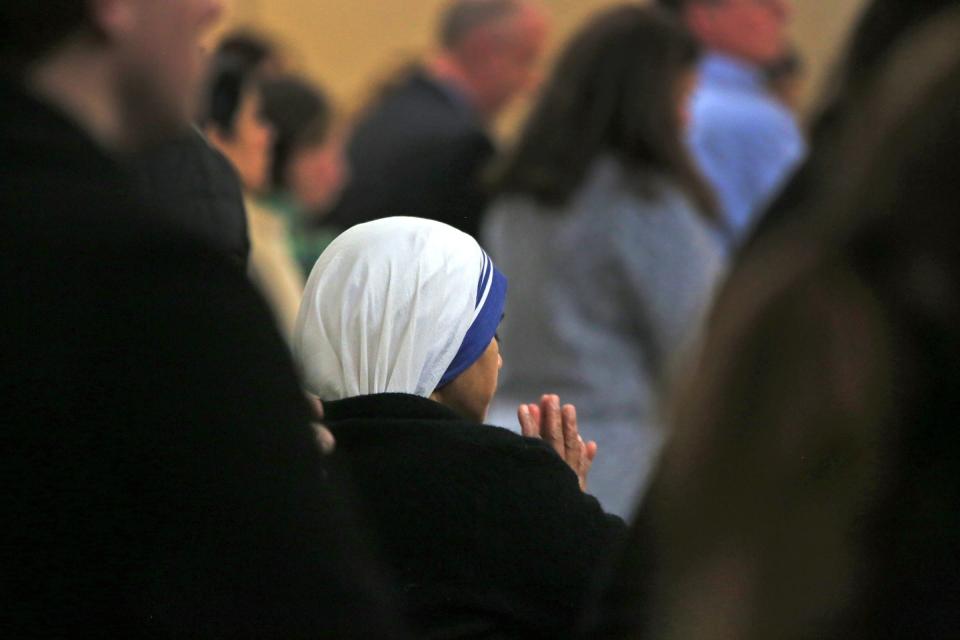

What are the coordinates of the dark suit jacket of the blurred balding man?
(323, 70, 494, 237)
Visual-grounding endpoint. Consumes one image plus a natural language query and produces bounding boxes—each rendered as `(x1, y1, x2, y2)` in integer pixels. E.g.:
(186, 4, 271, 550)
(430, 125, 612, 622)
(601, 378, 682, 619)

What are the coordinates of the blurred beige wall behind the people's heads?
(219, 0, 864, 129)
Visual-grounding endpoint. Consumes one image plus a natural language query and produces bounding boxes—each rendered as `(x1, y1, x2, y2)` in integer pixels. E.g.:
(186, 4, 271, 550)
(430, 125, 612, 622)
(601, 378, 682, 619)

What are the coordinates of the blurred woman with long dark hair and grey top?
(484, 6, 724, 515)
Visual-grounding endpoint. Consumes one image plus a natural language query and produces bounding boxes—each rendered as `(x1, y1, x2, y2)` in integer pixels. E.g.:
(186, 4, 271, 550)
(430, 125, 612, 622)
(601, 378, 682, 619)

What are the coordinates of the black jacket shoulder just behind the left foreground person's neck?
(130, 129, 250, 270)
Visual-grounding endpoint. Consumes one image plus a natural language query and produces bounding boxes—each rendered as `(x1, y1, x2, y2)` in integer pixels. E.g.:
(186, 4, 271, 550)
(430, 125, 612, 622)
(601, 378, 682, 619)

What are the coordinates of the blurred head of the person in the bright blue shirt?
(660, 0, 792, 65)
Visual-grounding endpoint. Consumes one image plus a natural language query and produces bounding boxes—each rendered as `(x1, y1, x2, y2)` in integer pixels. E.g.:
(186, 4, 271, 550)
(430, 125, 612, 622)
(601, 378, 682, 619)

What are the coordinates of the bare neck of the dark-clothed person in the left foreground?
(25, 44, 129, 152)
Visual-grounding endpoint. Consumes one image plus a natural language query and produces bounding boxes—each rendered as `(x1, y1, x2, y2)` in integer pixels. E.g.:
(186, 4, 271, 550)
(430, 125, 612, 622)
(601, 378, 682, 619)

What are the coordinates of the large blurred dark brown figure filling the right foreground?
(595, 8, 960, 640)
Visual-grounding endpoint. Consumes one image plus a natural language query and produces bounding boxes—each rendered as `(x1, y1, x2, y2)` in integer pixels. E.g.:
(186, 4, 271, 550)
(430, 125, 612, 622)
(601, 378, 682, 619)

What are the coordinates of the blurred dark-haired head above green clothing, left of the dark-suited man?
(263, 76, 348, 211)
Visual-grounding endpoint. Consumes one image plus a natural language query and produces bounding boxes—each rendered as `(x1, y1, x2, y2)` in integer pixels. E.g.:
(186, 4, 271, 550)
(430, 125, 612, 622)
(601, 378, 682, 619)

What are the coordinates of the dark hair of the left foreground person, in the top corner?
(0, 0, 89, 70)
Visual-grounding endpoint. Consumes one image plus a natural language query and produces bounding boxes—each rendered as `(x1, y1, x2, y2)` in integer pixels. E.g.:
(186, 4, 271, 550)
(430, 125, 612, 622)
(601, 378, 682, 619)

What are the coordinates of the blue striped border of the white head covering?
(437, 252, 507, 389)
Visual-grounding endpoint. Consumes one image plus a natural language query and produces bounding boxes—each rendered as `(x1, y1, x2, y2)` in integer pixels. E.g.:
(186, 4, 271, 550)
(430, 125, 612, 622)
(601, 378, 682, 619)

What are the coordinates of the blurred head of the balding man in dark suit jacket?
(440, 0, 548, 117)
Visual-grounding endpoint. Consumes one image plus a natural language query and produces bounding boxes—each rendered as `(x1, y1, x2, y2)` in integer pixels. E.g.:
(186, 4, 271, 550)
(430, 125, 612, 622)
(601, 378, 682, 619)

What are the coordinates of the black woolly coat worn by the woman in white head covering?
(326, 394, 624, 638)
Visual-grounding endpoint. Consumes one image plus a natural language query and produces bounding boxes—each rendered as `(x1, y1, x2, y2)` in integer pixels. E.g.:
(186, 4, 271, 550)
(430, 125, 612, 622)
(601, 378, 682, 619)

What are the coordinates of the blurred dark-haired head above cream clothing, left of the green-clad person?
(201, 57, 273, 193)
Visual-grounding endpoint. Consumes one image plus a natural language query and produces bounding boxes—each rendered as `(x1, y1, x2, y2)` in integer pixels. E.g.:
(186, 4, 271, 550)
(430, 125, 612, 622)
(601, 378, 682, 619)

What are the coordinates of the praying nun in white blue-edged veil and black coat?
(294, 218, 624, 638)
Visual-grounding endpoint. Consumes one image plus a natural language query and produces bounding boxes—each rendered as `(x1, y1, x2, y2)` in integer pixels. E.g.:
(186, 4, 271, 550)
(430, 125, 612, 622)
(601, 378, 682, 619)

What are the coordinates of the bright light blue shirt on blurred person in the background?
(689, 53, 806, 249)
